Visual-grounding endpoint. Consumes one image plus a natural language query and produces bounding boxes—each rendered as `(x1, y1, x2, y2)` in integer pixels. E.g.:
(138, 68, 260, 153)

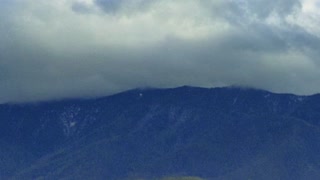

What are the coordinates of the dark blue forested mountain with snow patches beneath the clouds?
(0, 87, 320, 180)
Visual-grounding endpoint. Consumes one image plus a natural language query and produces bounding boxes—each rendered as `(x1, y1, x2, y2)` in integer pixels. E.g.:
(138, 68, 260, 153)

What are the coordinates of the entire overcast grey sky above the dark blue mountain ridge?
(0, 0, 320, 103)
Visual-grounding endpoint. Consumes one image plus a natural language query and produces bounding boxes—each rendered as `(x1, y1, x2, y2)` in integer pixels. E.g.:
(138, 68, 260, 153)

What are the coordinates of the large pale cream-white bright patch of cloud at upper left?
(11, 0, 230, 49)
